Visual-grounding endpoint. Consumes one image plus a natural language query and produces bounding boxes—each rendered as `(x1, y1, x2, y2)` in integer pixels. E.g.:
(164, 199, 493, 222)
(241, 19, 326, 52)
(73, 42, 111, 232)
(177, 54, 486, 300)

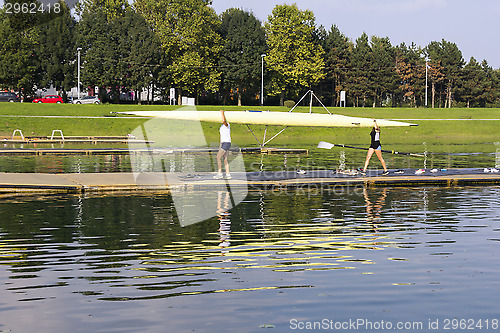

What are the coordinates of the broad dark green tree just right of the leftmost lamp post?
(79, 8, 156, 103)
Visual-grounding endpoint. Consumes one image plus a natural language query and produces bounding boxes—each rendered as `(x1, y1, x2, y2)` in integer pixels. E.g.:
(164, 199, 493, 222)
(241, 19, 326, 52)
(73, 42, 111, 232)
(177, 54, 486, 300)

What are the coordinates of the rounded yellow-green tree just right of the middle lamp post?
(265, 4, 325, 105)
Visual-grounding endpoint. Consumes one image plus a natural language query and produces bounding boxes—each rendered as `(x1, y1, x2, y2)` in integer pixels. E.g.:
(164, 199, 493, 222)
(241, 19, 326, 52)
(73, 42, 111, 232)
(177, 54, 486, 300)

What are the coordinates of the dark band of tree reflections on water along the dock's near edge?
(0, 188, 472, 260)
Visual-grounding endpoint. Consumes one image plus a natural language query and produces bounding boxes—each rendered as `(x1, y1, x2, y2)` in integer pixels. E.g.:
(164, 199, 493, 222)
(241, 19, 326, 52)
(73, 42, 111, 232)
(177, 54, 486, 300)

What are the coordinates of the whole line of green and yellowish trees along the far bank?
(0, 0, 500, 107)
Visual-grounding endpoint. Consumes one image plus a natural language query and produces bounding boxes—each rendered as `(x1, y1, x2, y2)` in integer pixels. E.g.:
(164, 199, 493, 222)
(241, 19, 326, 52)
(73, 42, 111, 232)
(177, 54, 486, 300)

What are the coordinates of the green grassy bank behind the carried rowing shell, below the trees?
(0, 103, 500, 149)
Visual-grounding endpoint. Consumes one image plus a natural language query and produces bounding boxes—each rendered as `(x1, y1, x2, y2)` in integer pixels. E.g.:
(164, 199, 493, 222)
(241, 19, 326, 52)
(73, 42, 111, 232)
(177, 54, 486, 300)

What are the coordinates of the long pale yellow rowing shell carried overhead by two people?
(117, 110, 418, 127)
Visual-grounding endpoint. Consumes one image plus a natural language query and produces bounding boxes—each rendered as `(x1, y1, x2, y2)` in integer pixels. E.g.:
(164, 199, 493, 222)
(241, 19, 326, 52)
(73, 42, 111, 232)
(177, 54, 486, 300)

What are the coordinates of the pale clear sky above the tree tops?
(212, 0, 500, 69)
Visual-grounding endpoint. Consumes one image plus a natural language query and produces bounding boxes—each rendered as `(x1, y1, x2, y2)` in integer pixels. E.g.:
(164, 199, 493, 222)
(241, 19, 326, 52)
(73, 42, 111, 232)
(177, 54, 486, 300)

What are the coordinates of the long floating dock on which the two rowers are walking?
(0, 169, 500, 194)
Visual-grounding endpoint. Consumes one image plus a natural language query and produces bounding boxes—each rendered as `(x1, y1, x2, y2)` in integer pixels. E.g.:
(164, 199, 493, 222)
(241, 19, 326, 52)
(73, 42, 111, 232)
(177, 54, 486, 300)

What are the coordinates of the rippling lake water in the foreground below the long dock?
(0, 186, 500, 333)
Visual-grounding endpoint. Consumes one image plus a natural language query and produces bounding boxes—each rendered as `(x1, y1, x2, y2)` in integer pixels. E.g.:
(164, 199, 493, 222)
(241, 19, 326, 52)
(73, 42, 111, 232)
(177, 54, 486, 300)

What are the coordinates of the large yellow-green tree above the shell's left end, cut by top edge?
(134, 0, 222, 101)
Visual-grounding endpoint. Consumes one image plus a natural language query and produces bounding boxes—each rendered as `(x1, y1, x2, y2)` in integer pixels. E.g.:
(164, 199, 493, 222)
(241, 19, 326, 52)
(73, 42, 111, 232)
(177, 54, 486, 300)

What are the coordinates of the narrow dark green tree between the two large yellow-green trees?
(219, 8, 266, 106)
